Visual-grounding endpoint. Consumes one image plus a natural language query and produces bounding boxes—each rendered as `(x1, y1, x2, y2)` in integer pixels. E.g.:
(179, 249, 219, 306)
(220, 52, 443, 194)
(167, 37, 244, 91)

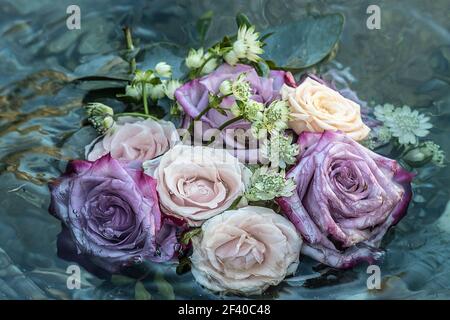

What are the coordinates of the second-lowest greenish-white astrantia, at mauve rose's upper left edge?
(262, 133, 299, 169)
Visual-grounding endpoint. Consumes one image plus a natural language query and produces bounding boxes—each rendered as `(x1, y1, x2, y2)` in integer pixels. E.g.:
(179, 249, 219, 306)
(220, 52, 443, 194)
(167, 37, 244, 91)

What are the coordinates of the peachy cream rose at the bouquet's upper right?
(281, 77, 370, 141)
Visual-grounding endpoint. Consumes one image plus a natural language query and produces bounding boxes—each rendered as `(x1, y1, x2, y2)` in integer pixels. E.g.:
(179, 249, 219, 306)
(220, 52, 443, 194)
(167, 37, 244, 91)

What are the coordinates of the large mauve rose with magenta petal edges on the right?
(277, 131, 413, 268)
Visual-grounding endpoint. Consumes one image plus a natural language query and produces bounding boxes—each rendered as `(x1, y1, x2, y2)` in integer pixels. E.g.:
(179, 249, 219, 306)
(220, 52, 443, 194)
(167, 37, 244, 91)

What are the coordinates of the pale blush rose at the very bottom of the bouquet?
(191, 206, 302, 295)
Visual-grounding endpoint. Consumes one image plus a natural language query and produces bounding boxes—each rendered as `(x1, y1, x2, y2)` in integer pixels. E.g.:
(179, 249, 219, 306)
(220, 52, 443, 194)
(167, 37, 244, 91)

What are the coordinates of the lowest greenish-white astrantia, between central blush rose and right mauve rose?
(245, 166, 295, 201)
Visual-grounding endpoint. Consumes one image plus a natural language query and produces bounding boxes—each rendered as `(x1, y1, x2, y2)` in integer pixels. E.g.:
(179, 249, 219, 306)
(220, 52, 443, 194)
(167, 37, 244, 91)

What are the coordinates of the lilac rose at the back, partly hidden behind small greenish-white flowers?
(175, 64, 295, 163)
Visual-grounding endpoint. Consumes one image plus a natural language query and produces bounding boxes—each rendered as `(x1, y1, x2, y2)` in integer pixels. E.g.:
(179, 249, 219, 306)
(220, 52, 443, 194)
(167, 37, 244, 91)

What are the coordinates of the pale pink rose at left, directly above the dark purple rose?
(86, 117, 180, 162)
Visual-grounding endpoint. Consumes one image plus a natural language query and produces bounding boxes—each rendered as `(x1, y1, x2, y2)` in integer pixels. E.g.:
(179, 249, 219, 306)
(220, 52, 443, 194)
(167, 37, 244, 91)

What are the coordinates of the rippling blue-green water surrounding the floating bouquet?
(0, 0, 450, 299)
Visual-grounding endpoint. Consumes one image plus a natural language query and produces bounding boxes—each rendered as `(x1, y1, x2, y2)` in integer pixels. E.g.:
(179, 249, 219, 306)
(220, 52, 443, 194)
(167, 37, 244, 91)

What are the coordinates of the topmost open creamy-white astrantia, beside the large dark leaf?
(233, 25, 264, 62)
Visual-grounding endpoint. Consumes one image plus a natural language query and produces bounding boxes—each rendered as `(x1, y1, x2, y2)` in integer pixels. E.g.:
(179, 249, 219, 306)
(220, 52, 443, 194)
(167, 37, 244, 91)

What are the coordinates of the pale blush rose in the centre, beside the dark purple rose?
(154, 145, 247, 226)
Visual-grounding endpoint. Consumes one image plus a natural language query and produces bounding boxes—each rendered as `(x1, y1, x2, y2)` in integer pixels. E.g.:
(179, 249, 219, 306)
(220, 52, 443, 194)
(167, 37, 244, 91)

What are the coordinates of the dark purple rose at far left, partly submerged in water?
(49, 154, 176, 272)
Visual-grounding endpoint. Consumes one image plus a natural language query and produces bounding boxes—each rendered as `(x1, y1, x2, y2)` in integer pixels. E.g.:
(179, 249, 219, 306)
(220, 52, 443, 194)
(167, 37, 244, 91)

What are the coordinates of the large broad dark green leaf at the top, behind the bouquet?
(264, 13, 344, 69)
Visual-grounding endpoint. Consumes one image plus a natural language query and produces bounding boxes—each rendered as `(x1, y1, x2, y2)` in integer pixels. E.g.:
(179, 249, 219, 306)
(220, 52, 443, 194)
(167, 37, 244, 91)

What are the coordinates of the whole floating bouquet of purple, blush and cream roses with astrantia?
(50, 15, 444, 295)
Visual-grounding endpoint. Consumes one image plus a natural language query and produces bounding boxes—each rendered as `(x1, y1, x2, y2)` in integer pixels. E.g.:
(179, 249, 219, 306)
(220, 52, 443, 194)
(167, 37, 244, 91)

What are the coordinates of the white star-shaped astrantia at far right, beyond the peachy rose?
(384, 106, 433, 144)
